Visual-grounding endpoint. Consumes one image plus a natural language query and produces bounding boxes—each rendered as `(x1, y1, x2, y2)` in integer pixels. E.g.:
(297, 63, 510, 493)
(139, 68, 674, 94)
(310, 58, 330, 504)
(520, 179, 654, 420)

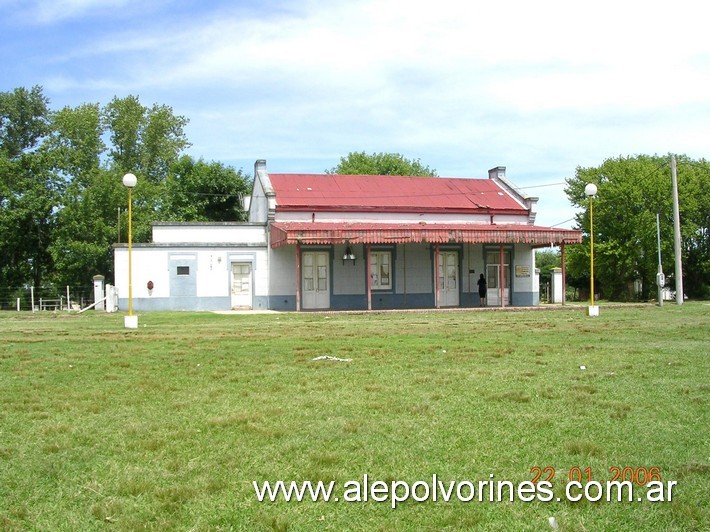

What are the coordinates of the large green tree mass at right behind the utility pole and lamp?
(565, 155, 710, 300)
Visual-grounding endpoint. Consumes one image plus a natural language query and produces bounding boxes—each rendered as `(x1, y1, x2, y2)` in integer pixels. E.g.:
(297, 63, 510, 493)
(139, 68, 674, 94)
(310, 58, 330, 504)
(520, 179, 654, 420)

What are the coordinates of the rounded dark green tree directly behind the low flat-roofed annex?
(160, 155, 250, 222)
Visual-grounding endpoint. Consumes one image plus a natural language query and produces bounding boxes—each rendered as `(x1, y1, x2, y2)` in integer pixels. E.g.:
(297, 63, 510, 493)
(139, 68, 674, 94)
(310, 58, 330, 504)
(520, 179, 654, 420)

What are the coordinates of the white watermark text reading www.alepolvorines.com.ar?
(252, 474, 677, 508)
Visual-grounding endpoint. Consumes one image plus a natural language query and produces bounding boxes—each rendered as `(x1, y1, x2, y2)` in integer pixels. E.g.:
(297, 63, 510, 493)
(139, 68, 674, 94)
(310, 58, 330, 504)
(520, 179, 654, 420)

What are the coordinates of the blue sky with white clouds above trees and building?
(0, 0, 710, 227)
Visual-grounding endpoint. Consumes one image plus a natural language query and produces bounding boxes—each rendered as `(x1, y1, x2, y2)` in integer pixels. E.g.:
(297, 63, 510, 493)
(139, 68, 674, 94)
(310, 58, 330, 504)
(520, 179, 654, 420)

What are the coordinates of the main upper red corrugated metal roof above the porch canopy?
(269, 174, 527, 214)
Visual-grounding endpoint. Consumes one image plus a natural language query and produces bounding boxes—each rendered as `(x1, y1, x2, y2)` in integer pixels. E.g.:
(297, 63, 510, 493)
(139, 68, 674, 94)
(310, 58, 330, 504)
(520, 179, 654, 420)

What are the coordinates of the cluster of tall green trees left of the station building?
(0, 86, 251, 306)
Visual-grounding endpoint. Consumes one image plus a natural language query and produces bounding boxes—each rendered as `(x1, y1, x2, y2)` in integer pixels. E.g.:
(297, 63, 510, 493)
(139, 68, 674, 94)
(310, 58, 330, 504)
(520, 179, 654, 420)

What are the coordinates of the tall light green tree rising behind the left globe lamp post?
(47, 96, 189, 285)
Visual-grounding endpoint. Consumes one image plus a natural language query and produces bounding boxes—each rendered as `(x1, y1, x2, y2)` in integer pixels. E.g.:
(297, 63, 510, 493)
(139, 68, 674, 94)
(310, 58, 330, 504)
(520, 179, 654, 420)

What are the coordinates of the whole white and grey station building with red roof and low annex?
(115, 160, 582, 311)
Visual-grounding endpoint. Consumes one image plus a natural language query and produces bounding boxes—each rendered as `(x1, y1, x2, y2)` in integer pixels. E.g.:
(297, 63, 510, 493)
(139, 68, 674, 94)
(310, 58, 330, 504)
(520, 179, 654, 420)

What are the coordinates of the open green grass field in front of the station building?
(0, 303, 710, 530)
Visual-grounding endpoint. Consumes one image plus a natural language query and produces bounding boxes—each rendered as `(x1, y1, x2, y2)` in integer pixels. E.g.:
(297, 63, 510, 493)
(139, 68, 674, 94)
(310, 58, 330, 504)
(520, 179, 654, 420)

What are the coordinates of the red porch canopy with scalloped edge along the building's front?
(271, 222, 582, 248)
